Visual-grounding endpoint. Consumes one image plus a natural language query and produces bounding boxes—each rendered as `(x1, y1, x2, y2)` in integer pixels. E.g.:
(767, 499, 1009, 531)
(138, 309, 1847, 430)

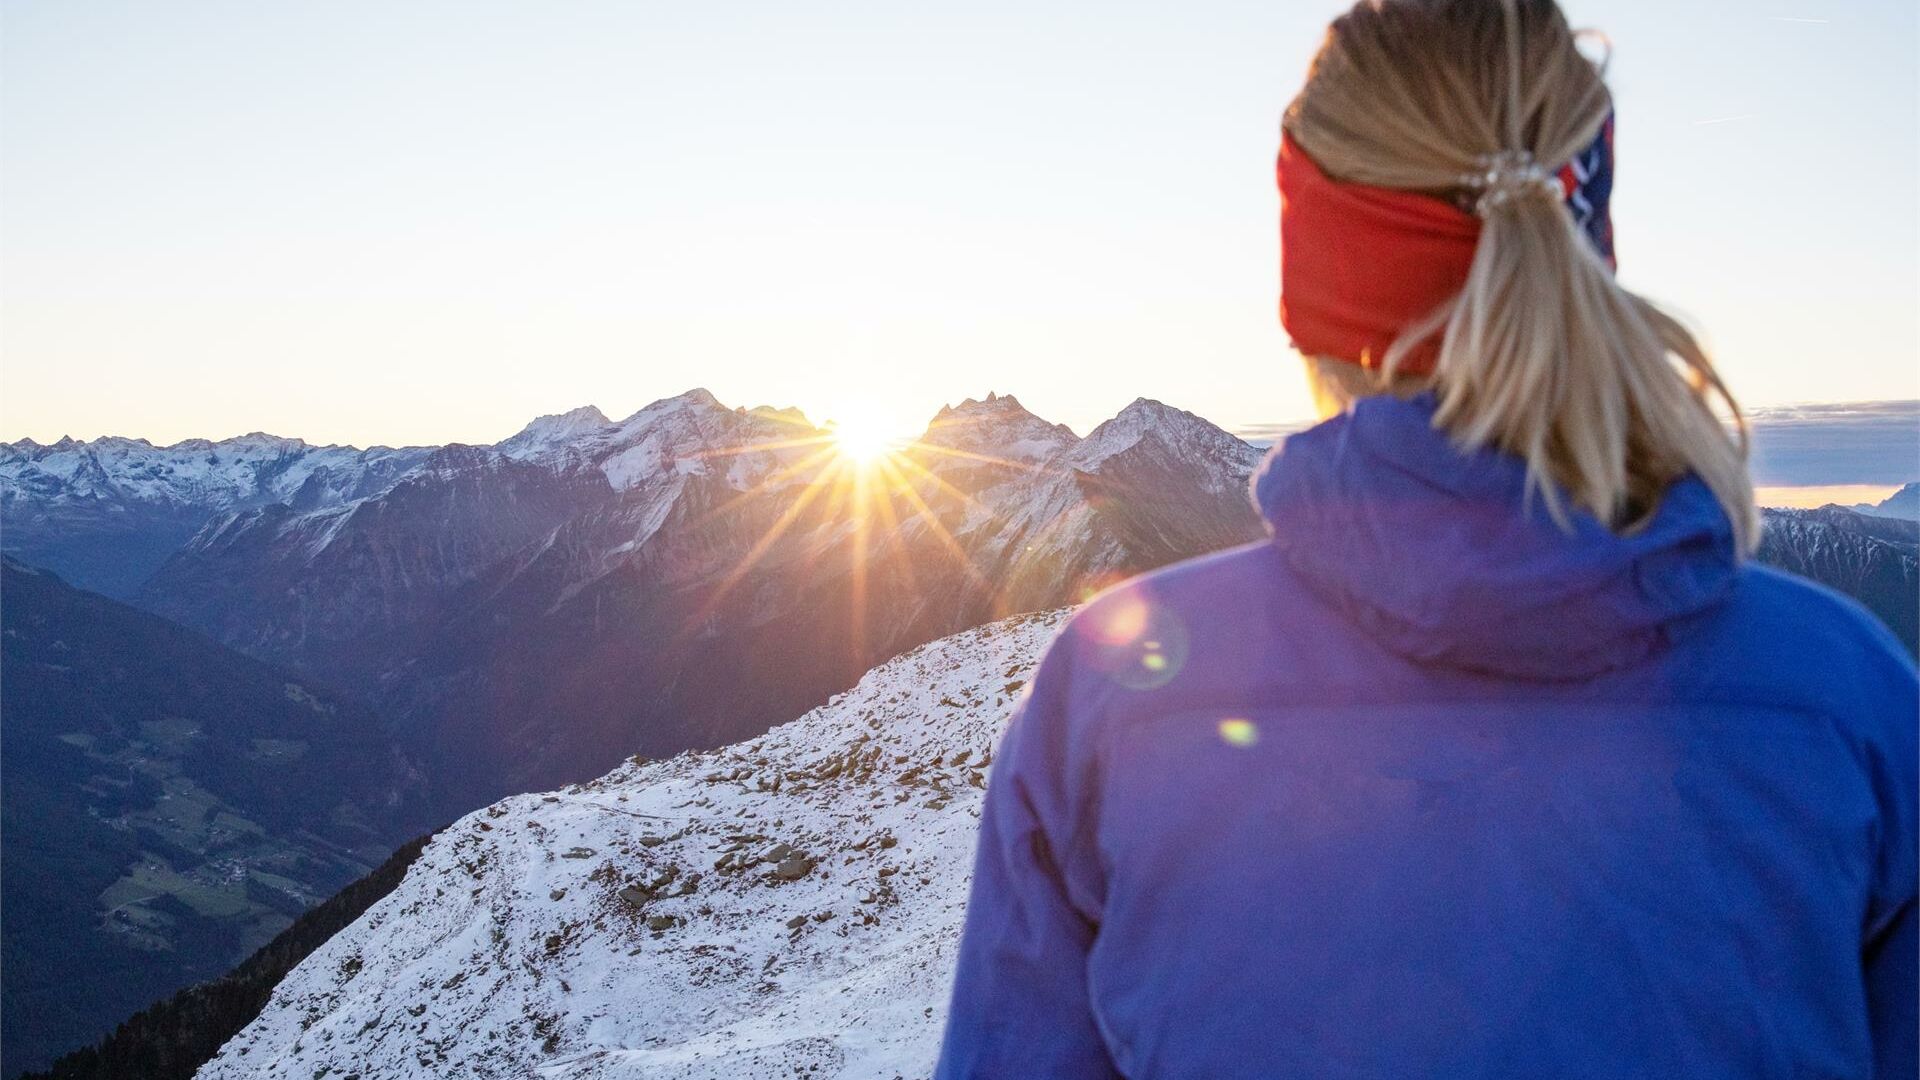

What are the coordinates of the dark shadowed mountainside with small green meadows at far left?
(0, 557, 428, 1074)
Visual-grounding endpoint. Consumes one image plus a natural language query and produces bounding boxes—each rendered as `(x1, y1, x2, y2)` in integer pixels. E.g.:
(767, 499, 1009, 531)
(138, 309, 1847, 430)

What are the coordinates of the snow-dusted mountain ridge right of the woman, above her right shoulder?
(1759, 505, 1920, 651)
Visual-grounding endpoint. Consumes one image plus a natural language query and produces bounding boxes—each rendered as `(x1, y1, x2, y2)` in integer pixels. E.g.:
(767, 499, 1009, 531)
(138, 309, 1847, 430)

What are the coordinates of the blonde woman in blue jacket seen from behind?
(939, 0, 1920, 1078)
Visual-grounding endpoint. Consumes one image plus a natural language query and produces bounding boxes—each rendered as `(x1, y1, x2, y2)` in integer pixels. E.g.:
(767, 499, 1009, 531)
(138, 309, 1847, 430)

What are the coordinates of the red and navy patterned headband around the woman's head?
(1279, 115, 1617, 375)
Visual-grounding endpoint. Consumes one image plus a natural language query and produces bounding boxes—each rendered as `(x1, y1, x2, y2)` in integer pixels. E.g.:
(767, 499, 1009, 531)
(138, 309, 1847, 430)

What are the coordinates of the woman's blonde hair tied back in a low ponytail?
(1284, 0, 1759, 552)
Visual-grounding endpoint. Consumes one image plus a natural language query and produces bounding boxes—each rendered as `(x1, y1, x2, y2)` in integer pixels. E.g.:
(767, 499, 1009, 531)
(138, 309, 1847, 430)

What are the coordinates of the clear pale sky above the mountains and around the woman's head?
(0, 0, 1920, 444)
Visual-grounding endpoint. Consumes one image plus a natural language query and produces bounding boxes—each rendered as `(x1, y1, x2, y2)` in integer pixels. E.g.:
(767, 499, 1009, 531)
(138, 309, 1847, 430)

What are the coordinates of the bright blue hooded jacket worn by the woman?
(937, 398, 1920, 1080)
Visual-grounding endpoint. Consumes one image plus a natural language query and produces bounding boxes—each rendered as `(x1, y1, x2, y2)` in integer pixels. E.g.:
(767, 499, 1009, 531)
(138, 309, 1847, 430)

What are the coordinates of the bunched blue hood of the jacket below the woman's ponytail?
(1254, 394, 1738, 678)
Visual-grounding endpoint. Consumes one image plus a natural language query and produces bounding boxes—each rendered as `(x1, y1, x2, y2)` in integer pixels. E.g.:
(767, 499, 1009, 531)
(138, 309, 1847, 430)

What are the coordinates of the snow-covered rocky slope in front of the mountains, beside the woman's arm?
(200, 611, 1064, 1080)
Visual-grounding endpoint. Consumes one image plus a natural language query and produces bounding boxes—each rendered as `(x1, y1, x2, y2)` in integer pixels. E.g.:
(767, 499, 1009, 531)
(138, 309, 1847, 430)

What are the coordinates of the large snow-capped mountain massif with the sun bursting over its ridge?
(86, 390, 1261, 811)
